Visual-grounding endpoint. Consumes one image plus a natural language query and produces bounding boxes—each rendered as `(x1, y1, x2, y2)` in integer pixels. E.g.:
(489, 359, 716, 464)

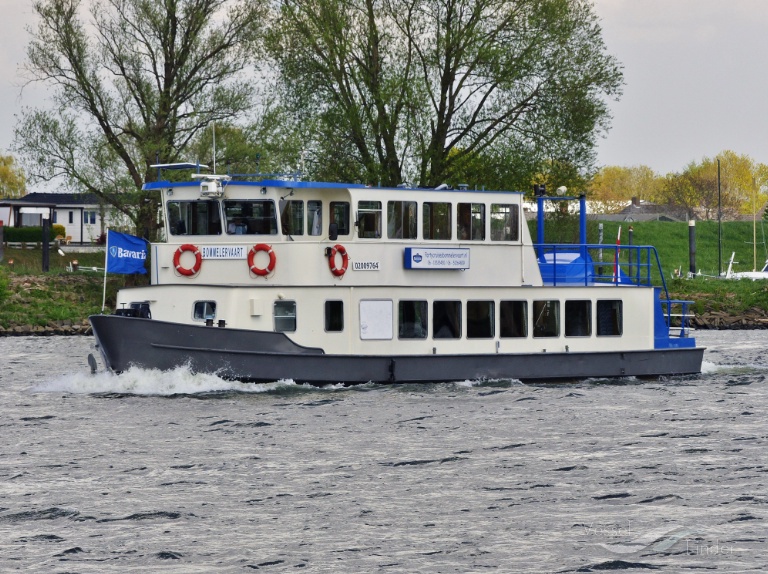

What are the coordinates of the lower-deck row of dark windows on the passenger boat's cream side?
(194, 300, 623, 339)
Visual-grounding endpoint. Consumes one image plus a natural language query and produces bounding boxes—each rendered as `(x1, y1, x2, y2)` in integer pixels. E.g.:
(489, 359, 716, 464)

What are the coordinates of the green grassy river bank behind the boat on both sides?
(0, 221, 768, 330)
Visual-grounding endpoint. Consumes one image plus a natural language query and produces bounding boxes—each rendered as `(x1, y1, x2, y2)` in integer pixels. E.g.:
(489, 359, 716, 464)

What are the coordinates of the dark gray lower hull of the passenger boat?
(90, 315, 704, 385)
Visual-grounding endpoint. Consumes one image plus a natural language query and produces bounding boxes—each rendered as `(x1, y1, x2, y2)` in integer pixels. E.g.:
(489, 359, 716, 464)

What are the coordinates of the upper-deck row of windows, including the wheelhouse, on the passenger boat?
(167, 199, 520, 241)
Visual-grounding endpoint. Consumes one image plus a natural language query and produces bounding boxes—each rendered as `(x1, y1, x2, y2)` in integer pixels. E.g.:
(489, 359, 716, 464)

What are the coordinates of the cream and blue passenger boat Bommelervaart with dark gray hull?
(90, 165, 704, 385)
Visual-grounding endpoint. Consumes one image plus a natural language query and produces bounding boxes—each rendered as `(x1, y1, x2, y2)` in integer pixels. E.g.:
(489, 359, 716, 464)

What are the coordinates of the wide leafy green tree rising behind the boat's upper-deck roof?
(269, 0, 623, 185)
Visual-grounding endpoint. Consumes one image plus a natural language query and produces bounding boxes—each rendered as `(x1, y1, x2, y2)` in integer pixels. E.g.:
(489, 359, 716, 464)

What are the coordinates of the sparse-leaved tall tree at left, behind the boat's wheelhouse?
(14, 0, 266, 238)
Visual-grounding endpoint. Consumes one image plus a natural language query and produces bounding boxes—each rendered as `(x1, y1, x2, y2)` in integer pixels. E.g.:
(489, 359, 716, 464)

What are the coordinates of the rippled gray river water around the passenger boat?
(0, 331, 768, 573)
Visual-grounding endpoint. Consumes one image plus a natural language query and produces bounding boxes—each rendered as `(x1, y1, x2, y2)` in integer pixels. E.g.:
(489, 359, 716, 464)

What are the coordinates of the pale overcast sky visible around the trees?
(0, 0, 768, 179)
